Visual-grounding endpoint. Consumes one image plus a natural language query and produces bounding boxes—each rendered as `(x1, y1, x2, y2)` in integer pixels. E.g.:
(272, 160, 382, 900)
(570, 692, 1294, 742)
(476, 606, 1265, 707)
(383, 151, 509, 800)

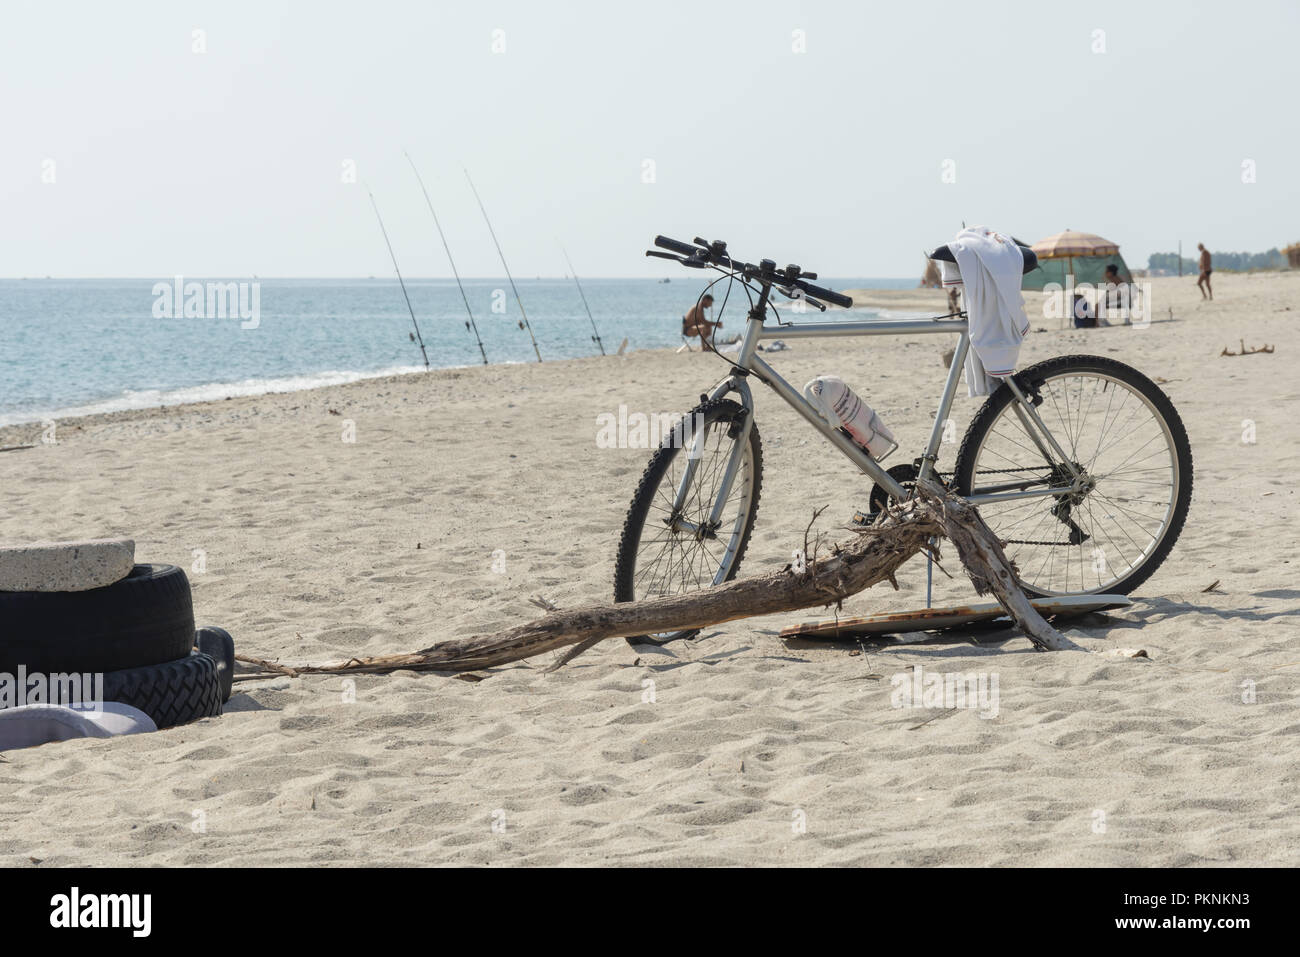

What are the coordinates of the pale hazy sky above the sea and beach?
(0, 0, 1300, 278)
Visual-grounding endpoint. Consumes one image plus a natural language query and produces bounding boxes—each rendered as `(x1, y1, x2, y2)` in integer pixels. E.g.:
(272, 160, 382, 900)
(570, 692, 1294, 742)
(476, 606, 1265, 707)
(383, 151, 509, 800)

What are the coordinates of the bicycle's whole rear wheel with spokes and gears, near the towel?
(954, 355, 1192, 597)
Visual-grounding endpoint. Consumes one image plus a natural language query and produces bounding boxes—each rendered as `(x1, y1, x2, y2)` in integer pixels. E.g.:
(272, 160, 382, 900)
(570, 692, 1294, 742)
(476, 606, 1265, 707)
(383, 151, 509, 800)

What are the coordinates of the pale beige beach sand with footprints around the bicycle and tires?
(0, 273, 1300, 867)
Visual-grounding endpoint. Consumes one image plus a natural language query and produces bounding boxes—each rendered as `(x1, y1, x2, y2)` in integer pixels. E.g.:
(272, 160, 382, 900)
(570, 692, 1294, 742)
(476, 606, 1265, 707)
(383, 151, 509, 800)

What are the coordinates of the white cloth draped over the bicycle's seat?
(948, 226, 1030, 397)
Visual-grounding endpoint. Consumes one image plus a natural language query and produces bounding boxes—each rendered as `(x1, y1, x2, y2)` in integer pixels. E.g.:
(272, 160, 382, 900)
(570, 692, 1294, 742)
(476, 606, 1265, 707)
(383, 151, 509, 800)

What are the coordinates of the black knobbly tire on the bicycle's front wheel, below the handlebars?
(614, 399, 763, 645)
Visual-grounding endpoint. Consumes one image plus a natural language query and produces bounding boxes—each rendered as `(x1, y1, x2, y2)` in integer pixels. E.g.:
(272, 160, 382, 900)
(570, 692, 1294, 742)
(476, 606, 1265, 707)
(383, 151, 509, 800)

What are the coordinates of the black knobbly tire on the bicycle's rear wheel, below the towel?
(954, 355, 1192, 597)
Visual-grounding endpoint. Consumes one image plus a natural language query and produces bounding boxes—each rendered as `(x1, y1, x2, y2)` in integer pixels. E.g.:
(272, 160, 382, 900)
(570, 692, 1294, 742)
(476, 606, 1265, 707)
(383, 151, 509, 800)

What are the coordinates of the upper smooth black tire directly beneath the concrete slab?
(0, 564, 194, 674)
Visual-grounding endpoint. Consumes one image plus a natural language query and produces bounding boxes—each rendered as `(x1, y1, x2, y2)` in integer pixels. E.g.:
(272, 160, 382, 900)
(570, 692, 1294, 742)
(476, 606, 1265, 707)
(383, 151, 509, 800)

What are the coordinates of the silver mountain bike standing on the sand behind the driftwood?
(614, 235, 1192, 644)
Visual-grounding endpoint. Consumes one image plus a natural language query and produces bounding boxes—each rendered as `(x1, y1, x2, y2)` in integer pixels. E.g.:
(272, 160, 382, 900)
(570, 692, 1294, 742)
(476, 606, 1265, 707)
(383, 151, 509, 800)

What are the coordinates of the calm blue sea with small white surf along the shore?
(0, 277, 917, 426)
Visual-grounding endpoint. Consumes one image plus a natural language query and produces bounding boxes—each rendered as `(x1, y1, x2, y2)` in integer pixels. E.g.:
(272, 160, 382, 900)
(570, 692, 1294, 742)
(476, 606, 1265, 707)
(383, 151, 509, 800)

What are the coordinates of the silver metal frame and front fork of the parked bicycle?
(673, 283, 1082, 531)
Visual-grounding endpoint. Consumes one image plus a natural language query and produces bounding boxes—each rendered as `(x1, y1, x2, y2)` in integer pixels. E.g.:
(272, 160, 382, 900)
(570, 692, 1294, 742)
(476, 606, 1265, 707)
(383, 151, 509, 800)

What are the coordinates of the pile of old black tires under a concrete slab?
(0, 564, 224, 728)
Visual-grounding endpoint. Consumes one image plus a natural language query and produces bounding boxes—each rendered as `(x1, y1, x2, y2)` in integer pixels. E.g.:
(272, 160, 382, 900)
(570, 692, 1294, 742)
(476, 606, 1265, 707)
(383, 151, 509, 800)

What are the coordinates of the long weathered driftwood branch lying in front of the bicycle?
(239, 482, 1079, 676)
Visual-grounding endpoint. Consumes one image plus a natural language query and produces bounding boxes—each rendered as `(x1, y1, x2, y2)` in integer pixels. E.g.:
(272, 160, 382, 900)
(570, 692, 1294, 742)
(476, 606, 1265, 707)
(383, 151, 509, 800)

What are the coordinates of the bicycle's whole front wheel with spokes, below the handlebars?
(614, 399, 763, 645)
